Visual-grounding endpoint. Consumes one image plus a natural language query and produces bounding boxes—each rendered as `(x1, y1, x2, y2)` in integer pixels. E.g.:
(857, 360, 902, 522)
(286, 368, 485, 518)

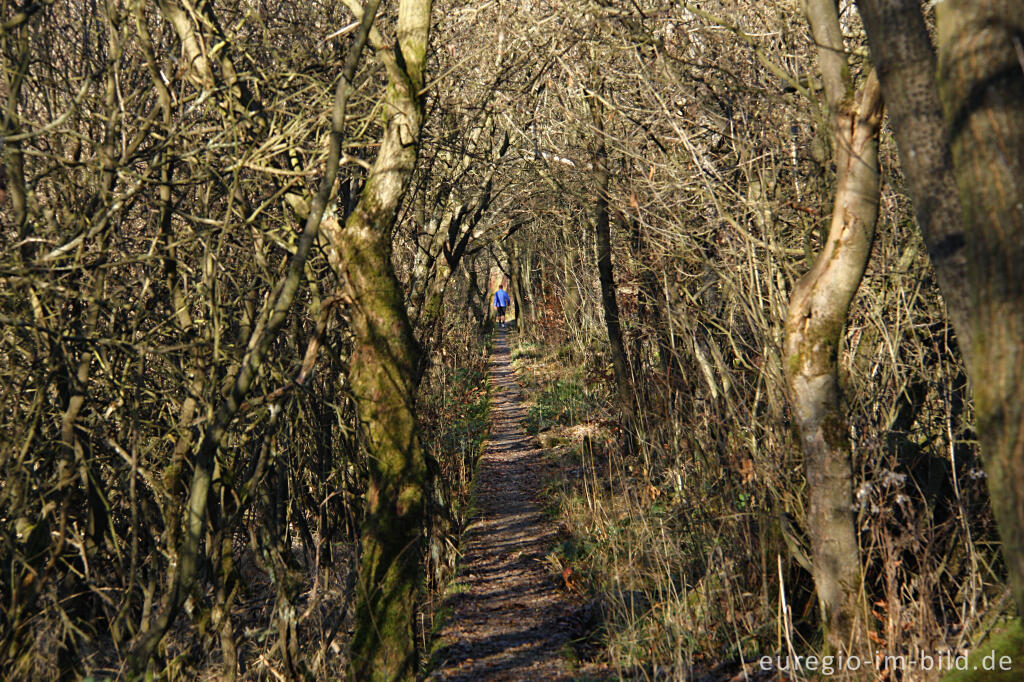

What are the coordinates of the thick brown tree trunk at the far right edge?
(936, 0, 1024, 616)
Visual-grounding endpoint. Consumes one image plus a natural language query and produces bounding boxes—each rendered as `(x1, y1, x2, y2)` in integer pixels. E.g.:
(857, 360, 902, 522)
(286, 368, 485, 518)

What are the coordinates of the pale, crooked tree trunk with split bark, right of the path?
(784, 0, 882, 653)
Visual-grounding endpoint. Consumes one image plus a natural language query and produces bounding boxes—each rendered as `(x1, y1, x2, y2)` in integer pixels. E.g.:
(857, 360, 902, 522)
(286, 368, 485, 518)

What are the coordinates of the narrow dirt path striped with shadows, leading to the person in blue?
(431, 331, 572, 681)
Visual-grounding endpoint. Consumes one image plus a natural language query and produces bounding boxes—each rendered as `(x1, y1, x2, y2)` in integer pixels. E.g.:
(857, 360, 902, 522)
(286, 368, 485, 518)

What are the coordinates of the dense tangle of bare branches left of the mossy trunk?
(0, 0, 495, 679)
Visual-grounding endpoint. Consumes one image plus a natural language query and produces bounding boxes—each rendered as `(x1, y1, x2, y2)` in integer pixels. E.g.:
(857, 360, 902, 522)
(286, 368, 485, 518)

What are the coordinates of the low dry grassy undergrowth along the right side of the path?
(514, 327, 999, 681)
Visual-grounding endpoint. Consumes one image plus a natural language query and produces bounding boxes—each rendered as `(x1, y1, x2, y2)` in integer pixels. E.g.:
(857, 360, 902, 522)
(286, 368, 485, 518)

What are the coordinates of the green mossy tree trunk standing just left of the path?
(324, 0, 431, 680)
